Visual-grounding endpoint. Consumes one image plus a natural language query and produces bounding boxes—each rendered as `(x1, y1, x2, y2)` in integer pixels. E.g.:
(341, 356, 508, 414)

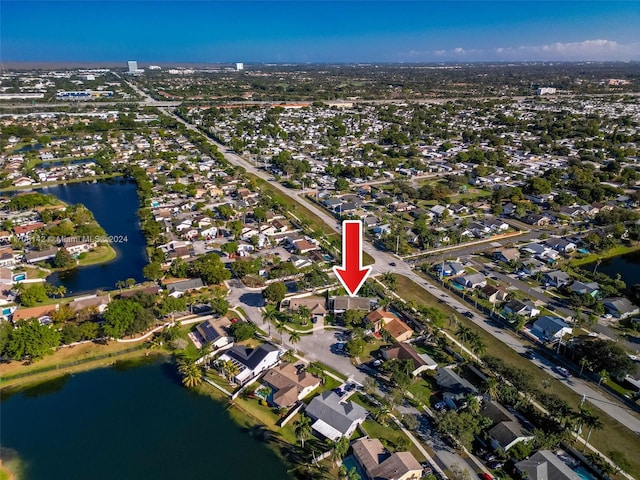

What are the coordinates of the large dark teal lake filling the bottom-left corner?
(0, 362, 290, 480)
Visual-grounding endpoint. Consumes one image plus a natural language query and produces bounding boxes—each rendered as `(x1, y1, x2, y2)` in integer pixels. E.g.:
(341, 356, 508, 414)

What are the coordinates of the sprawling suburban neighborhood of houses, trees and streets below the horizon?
(0, 61, 640, 480)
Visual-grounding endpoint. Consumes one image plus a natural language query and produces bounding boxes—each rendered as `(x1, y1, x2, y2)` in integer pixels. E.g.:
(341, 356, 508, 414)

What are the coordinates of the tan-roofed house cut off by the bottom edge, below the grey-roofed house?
(351, 438, 423, 480)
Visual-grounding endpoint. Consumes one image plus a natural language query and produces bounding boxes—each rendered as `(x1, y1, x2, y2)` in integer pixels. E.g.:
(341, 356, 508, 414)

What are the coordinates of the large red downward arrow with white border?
(333, 220, 371, 297)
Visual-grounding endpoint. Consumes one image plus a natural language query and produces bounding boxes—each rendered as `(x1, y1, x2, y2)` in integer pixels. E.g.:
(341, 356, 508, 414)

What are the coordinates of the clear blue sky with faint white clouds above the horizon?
(0, 0, 640, 62)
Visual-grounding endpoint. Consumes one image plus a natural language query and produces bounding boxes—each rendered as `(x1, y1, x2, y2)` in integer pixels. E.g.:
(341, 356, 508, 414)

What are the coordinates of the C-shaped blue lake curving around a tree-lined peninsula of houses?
(39, 178, 147, 295)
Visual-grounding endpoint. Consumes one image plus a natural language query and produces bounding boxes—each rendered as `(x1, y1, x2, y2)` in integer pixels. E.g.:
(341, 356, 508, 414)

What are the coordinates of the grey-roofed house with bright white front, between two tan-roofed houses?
(305, 390, 369, 441)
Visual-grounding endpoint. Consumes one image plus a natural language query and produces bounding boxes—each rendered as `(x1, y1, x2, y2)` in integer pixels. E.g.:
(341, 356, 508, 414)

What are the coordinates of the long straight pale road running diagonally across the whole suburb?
(120, 78, 640, 434)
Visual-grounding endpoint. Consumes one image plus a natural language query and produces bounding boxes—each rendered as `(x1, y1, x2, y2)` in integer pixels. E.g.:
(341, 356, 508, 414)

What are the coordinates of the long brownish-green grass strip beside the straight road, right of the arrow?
(396, 275, 640, 477)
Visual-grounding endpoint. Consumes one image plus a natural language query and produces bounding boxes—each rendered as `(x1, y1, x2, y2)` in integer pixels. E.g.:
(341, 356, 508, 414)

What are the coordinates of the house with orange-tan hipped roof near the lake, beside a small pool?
(262, 363, 320, 408)
